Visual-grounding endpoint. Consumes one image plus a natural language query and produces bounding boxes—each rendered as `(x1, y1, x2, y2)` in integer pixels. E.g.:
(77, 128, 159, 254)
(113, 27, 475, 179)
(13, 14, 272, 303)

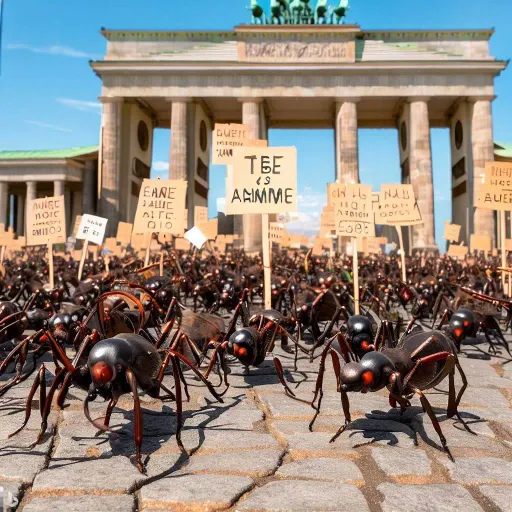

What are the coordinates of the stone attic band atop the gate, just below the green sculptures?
(102, 25, 500, 62)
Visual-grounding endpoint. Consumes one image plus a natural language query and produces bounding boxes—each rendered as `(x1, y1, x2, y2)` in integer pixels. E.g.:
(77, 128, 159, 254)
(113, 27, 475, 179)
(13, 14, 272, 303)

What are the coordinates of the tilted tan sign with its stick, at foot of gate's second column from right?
(374, 184, 423, 282)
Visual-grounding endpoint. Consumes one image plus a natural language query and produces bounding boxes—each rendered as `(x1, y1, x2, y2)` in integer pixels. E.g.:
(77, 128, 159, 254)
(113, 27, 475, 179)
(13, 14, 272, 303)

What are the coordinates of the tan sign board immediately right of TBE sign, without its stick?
(331, 184, 375, 238)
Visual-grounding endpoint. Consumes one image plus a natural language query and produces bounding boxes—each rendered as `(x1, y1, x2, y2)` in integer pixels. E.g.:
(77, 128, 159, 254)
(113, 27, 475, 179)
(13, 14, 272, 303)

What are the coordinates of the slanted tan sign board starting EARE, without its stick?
(133, 179, 187, 235)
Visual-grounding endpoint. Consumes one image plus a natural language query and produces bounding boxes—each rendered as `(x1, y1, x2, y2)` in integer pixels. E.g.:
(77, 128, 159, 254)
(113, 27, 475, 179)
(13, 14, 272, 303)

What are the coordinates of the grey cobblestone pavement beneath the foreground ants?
(0, 330, 512, 512)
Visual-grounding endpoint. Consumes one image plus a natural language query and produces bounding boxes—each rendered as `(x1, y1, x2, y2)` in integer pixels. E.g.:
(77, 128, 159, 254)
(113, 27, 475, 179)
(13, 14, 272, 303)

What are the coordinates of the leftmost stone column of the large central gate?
(99, 98, 123, 236)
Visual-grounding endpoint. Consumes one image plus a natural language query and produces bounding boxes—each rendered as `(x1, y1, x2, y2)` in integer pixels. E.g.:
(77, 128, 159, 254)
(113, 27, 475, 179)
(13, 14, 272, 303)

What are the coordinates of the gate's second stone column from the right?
(409, 98, 436, 250)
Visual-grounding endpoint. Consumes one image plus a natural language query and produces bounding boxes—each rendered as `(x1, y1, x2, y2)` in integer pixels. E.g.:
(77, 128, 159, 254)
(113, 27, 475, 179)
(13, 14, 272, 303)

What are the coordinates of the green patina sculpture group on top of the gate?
(248, 0, 350, 25)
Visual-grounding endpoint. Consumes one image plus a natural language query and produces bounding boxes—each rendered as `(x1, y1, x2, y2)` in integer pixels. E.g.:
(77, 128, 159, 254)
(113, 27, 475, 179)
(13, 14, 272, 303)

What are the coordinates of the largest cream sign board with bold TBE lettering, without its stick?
(226, 147, 297, 215)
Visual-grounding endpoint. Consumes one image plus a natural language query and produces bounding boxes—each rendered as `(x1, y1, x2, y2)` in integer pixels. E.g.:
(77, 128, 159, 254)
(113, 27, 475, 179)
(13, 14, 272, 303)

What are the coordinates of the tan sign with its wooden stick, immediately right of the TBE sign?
(330, 183, 375, 315)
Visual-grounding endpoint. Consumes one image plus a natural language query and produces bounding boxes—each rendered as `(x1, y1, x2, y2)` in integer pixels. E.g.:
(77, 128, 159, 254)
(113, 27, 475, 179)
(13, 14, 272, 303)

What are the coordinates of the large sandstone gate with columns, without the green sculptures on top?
(91, 25, 506, 251)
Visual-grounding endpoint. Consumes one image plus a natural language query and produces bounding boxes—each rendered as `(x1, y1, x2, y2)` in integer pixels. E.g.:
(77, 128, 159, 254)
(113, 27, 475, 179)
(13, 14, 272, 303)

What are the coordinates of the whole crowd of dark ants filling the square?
(0, 244, 512, 472)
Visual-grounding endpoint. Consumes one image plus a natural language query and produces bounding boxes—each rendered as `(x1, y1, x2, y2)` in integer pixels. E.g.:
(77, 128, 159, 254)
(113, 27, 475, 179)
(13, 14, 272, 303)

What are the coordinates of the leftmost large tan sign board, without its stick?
(27, 196, 66, 245)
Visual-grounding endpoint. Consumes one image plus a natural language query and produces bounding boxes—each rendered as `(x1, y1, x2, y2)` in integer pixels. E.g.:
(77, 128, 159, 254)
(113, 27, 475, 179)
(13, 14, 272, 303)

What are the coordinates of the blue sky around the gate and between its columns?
(0, 0, 512, 247)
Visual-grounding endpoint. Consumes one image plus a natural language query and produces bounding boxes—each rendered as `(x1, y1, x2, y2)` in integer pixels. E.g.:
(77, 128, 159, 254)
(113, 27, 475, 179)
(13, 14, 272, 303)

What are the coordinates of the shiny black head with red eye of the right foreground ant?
(340, 352, 394, 393)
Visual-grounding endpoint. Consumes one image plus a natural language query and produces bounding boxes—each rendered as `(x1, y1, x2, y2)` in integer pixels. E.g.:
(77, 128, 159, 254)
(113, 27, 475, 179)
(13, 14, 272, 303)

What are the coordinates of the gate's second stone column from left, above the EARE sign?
(169, 99, 193, 180)
